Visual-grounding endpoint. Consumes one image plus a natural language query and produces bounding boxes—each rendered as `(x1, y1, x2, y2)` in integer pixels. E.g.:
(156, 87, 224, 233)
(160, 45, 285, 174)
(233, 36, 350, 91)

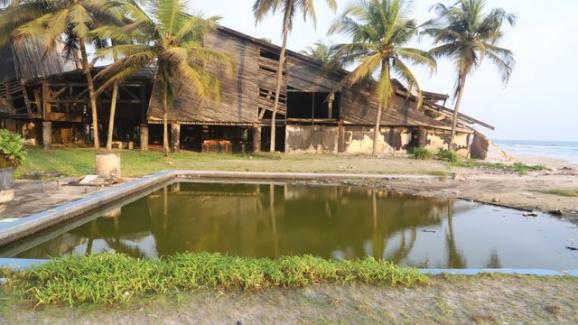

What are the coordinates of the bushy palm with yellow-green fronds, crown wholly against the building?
(94, 0, 233, 155)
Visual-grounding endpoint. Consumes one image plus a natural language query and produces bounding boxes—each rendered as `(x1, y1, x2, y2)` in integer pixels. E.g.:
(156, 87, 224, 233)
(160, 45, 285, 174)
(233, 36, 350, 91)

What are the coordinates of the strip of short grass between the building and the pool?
(16, 148, 447, 178)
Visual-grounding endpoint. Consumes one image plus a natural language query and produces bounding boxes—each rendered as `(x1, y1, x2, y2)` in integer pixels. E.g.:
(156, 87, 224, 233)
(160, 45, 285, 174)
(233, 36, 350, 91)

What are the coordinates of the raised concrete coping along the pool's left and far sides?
(0, 170, 439, 247)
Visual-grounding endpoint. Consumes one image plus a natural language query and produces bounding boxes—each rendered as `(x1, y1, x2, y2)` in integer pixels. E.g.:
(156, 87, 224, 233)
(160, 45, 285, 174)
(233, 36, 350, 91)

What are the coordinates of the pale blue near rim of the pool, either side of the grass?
(0, 258, 578, 277)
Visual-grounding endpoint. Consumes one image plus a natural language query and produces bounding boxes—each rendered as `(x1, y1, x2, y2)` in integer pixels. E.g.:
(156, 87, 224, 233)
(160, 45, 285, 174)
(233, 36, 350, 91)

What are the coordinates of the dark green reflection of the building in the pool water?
(14, 183, 476, 265)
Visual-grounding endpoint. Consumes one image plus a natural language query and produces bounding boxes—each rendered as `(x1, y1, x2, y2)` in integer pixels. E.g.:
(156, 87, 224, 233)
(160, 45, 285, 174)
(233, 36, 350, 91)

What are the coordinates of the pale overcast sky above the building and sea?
(190, 0, 578, 141)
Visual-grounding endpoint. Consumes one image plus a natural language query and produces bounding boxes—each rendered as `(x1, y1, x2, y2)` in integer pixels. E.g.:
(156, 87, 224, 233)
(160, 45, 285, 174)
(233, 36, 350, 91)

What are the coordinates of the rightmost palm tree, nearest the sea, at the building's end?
(425, 0, 516, 150)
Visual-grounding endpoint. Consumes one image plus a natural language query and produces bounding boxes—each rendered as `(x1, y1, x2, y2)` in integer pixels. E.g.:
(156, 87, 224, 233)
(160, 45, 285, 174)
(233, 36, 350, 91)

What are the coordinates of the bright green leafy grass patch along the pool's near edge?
(5, 253, 428, 306)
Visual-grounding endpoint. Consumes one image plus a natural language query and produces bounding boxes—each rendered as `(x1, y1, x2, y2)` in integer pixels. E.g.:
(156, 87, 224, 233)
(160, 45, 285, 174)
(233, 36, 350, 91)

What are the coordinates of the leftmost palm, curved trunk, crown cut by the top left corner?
(0, 0, 124, 150)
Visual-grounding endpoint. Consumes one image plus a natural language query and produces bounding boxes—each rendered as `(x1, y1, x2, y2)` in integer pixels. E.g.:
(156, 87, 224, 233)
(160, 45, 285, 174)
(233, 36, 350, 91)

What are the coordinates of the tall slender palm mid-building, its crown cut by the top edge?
(253, 0, 337, 152)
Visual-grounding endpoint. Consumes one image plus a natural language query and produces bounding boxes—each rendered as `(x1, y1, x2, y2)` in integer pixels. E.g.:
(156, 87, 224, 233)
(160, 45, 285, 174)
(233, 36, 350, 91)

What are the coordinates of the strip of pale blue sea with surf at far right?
(493, 140, 578, 164)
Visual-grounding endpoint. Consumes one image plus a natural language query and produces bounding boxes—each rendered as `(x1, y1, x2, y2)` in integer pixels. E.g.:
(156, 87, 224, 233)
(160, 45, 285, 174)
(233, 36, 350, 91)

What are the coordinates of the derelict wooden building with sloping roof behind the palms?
(0, 27, 493, 155)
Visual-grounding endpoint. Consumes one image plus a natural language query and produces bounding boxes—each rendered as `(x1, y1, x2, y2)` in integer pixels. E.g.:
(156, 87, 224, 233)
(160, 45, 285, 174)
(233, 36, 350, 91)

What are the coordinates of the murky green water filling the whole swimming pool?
(4, 183, 578, 270)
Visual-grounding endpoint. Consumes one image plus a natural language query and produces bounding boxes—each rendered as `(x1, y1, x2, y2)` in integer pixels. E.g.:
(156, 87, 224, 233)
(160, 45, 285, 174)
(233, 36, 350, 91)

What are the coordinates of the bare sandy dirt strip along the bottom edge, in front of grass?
(0, 276, 578, 324)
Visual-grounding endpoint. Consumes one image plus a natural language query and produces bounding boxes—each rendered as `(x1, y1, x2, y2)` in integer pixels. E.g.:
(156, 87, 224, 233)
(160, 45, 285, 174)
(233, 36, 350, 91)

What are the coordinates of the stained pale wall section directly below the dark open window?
(285, 125, 339, 154)
